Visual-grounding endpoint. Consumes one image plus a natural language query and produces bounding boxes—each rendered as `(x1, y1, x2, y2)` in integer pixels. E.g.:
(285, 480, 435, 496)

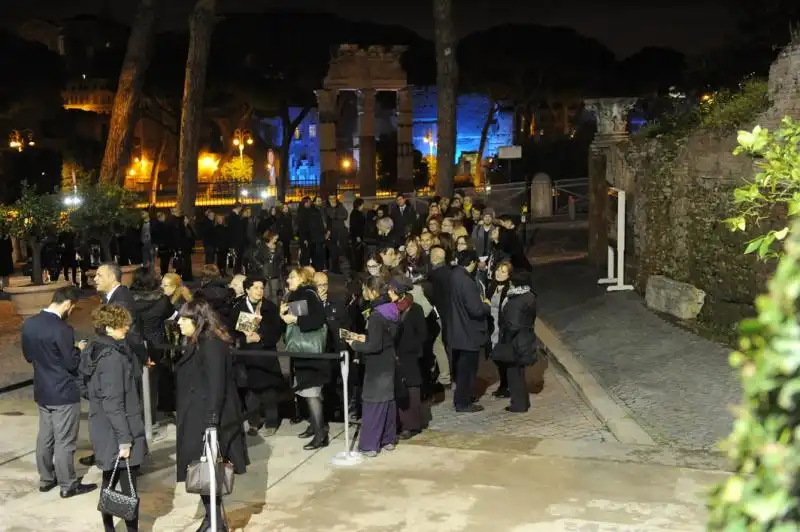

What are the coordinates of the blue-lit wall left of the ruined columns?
(264, 107, 321, 187)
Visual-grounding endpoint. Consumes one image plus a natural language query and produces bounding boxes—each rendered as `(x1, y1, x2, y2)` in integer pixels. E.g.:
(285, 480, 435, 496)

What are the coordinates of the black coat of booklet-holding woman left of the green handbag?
(230, 297, 286, 390)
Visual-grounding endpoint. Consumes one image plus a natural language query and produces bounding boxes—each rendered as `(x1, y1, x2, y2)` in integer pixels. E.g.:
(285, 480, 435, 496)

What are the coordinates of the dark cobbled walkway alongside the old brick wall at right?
(534, 261, 740, 449)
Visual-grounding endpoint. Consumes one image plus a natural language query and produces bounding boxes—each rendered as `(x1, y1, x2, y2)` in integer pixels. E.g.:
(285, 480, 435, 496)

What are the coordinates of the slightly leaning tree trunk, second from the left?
(177, 0, 216, 216)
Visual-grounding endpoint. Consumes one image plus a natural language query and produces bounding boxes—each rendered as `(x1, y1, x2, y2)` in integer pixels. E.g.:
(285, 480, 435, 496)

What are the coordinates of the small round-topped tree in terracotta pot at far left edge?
(0, 187, 70, 316)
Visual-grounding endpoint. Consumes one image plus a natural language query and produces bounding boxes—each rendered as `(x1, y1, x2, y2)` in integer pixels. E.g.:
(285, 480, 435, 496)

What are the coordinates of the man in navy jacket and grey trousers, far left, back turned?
(22, 288, 97, 499)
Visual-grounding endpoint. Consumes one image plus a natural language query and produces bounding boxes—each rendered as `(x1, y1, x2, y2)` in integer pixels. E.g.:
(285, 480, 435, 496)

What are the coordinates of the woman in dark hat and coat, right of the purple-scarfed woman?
(389, 277, 428, 440)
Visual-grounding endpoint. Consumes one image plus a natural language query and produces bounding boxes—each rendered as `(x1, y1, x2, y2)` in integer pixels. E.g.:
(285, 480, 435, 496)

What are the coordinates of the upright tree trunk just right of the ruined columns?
(433, 0, 458, 197)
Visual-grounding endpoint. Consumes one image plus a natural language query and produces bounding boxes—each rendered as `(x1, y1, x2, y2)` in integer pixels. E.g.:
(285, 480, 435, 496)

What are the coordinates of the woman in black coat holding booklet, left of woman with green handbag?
(231, 277, 286, 436)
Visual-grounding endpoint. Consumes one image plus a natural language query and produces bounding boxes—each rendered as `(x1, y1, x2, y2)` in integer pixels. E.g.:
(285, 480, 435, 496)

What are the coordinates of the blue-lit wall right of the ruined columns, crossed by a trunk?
(412, 87, 514, 162)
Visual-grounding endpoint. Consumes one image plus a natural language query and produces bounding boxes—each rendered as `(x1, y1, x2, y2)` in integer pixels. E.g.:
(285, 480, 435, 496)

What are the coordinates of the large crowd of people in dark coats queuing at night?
(22, 194, 536, 531)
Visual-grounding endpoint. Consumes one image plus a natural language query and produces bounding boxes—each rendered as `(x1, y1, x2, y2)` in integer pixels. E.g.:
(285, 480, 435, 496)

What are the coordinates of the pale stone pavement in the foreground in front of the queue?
(0, 401, 724, 532)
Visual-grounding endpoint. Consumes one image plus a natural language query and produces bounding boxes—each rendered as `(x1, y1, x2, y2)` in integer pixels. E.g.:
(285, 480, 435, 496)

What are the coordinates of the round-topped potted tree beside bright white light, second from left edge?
(69, 183, 141, 281)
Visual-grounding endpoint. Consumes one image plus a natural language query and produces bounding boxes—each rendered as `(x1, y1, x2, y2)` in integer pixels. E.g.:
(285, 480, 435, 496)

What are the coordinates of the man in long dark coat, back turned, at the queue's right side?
(445, 249, 491, 412)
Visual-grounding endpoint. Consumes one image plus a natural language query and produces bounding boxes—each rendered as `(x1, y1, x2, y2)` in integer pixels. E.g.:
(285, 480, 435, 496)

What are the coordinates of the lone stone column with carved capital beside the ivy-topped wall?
(584, 98, 636, 266)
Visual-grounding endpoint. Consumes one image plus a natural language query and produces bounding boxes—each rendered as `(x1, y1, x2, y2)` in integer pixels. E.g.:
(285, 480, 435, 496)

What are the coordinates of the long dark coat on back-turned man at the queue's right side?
(445, 266, 492, 351)
